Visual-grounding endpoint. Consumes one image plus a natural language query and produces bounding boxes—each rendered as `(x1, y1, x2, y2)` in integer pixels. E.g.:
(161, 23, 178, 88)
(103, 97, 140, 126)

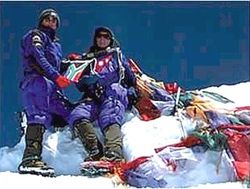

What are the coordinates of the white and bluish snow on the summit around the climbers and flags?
(0, 82, 250, 189)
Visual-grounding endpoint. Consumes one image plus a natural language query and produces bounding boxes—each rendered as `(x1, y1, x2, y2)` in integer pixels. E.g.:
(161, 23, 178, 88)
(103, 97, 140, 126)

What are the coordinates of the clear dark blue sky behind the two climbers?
(0, 1, 250, 146)
